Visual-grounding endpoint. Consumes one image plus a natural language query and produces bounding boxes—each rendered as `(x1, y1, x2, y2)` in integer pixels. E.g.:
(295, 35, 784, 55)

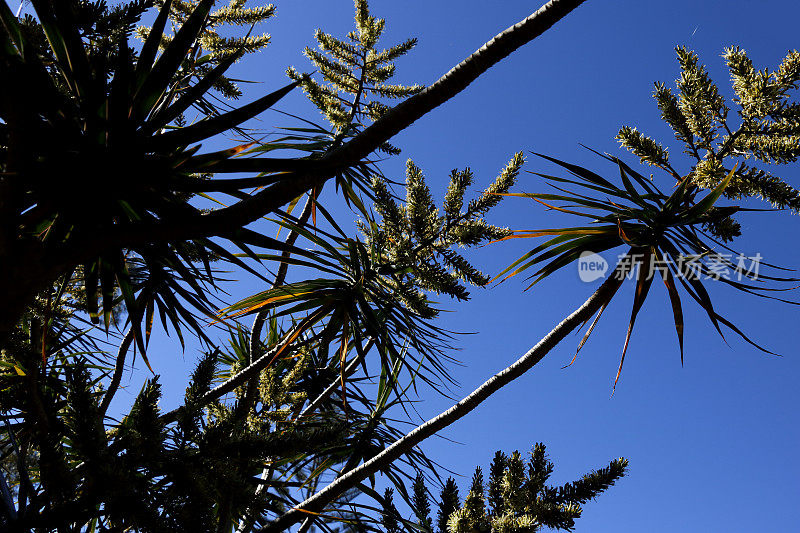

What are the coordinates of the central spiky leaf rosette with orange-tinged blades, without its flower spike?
(222, 205, 460, 394)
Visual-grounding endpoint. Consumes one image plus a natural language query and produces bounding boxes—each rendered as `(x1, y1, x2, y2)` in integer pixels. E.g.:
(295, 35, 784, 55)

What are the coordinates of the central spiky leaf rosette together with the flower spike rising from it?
(222, 154, 523, 392)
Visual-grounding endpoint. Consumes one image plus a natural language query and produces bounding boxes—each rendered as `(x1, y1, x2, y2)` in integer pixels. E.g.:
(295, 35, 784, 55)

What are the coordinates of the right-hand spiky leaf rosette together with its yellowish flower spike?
(490, 47, 800, 392)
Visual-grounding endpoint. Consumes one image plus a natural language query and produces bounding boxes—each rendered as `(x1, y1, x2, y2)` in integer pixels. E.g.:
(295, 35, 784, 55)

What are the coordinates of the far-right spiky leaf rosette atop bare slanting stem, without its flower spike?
(495, 154, 797, 386)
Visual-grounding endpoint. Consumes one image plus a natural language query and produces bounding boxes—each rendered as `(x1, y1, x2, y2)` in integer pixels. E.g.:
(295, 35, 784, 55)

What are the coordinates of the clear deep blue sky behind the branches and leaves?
(111, 0, 800, 533)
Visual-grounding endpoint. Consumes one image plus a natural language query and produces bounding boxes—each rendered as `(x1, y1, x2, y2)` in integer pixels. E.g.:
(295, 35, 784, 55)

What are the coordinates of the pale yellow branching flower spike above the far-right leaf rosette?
(617, 47, 800, 240)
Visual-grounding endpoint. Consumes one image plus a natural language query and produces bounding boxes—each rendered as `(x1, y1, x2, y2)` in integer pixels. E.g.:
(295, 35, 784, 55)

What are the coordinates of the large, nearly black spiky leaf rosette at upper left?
(0, 0, 304, 353)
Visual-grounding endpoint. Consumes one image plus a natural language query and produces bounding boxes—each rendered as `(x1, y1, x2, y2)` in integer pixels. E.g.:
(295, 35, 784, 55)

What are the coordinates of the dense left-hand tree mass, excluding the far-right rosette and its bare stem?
(0, 0, 624, 531)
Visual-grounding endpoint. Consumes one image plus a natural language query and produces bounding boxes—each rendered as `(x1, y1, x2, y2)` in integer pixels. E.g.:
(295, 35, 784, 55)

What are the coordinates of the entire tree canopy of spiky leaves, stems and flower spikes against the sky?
(0, 0, 800, 533)
